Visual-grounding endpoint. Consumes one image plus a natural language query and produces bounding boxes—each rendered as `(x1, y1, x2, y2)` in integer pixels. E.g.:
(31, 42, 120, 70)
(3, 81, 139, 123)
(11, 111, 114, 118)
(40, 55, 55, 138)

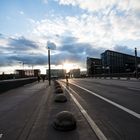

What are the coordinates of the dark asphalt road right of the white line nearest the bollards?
(64, 79, 140, 140)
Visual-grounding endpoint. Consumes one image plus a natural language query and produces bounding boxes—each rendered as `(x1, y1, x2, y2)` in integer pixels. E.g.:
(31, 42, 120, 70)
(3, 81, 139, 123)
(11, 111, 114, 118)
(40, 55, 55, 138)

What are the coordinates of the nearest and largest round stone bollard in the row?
(53, 111, 76, 131)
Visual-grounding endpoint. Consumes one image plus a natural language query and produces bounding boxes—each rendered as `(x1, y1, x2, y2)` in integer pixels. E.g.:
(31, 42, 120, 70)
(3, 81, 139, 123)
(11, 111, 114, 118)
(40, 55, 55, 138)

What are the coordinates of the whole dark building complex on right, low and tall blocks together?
(87, 50, 140, 76)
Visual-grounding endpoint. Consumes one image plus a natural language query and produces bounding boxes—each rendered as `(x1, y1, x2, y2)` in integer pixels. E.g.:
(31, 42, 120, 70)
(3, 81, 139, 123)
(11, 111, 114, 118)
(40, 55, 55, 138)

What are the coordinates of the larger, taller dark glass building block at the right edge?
(101, 50, 140, 74)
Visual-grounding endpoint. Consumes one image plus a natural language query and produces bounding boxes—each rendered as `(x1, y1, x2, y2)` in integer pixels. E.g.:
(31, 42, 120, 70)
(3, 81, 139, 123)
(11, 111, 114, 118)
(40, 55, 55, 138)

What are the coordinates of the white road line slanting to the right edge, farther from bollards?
(71, 83, 140, 119)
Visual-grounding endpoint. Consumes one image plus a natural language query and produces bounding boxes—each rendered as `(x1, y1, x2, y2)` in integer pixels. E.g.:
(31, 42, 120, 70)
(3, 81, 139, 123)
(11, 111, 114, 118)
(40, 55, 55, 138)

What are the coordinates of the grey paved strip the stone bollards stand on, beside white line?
(25, 82, 97, 140)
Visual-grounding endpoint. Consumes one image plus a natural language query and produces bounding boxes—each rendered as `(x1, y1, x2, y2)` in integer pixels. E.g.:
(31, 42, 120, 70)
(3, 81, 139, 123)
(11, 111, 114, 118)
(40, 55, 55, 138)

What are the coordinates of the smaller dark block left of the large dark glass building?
(87, 57, 102, 76)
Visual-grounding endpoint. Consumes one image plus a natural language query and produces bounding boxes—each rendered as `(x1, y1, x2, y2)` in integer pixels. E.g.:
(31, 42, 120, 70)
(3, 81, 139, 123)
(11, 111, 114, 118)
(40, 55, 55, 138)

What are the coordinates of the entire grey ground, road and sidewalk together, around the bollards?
(0, 79, 140, 140)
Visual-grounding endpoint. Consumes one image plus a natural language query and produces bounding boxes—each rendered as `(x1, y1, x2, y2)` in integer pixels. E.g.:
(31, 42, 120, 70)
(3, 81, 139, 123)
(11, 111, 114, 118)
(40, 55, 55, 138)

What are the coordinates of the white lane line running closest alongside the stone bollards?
(62, 84, 107, 140)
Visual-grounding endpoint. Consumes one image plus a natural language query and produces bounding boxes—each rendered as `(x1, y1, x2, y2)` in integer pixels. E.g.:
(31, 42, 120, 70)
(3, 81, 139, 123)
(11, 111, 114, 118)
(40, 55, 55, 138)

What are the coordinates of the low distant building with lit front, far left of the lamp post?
(15, 69, 40, 77)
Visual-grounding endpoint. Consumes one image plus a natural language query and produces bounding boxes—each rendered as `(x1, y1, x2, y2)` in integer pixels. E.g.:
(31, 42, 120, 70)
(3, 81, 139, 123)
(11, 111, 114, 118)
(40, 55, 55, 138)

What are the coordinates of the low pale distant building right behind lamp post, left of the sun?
(47, 69, 66, 78)
